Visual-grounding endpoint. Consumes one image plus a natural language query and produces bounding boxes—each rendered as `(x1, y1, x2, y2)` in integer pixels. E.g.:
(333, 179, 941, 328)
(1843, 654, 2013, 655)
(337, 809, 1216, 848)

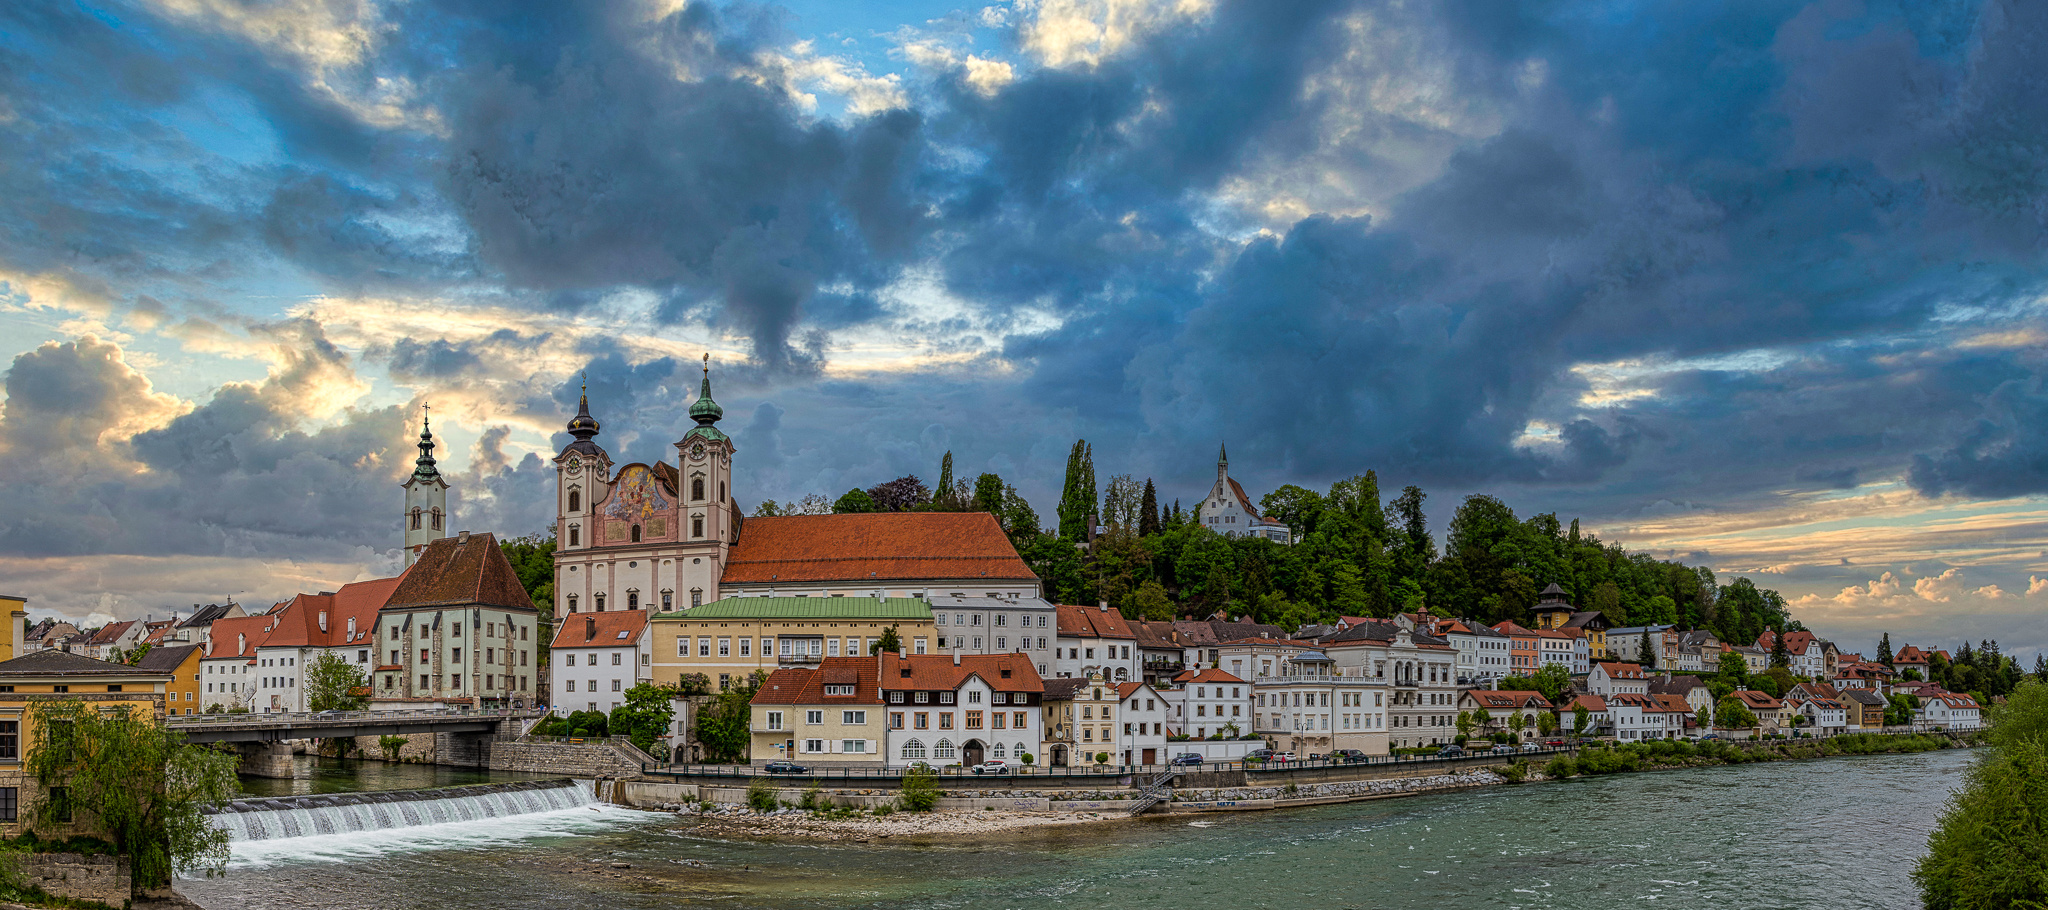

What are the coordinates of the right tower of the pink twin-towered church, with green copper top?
(676, 355, 739, 607)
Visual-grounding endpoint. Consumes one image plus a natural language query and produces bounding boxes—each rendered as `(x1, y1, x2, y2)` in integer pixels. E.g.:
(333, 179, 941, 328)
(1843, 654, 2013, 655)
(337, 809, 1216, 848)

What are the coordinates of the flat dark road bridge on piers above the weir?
(164, 709, 547, 777)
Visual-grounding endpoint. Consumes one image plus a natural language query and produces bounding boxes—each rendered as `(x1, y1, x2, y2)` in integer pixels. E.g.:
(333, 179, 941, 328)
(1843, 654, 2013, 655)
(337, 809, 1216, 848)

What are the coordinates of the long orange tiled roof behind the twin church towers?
(723, 512, 1038, 584)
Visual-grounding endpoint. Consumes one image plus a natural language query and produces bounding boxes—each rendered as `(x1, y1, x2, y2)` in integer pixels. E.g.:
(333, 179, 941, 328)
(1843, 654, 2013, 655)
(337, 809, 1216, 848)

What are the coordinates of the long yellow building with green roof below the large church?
(649, 596, 938, 689)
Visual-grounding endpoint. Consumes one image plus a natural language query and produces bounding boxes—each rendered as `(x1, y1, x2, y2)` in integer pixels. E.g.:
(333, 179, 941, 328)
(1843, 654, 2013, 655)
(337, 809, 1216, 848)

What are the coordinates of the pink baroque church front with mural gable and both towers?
(555, 355, 739, 617)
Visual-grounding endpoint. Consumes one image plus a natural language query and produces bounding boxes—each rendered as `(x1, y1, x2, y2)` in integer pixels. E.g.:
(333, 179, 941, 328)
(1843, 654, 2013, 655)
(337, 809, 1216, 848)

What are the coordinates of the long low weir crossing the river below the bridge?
(213, 779, 596, 842)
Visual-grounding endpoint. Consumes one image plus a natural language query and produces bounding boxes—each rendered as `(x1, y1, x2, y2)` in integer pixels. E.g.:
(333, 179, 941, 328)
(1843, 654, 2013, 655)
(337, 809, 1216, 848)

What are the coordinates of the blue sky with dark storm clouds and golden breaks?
(0, 0, 2048, 664)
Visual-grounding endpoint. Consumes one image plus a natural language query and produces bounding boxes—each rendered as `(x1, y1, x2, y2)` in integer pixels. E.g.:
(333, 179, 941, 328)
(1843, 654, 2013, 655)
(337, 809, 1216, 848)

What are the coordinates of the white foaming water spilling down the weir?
(213, 781, 649, 869)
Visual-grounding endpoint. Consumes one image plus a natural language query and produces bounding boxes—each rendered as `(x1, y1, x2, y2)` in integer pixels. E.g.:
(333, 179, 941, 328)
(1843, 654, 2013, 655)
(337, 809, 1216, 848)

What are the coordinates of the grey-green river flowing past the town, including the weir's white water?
(178, 750, 1974, 910)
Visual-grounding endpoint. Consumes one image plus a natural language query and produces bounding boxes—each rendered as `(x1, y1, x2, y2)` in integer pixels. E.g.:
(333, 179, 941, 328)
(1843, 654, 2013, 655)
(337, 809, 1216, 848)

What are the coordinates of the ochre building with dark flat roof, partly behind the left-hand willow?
(0, 650, 170, 836)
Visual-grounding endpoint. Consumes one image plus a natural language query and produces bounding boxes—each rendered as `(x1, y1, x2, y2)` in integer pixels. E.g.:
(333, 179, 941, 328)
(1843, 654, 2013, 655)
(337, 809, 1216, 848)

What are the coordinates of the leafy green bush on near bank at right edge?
(1913, 683, 2048, 910)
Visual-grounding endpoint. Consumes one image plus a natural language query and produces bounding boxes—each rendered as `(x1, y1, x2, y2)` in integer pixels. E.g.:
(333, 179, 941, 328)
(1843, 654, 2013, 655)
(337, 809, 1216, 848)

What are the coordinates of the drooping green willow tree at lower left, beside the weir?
(25, 699, 240, 894)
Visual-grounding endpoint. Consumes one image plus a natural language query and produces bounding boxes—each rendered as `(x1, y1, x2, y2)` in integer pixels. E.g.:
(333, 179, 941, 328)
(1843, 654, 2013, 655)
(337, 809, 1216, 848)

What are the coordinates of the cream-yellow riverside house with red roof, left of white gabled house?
(748, 658, 887, 769)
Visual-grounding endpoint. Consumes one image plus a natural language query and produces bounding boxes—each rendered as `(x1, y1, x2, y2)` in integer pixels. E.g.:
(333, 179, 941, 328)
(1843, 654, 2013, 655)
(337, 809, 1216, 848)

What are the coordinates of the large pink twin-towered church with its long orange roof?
(555, 355, 1051, 627)
